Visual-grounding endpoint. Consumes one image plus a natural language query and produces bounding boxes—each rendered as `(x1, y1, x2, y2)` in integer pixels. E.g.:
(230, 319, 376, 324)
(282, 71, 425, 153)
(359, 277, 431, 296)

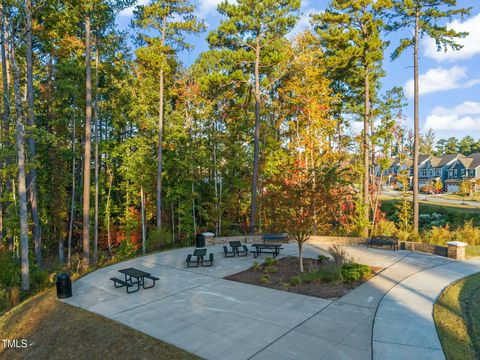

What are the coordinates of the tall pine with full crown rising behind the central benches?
(208, 0, 300, 235)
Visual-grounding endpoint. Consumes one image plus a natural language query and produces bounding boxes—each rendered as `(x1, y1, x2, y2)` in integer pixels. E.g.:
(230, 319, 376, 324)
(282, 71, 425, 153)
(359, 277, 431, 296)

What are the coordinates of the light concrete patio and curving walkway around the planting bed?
(65, 244, 480, 360)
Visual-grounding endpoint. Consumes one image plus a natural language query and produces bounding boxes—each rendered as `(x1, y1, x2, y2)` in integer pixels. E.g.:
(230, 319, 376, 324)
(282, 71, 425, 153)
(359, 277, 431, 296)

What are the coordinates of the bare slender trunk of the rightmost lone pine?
(413, 10, 420, 232)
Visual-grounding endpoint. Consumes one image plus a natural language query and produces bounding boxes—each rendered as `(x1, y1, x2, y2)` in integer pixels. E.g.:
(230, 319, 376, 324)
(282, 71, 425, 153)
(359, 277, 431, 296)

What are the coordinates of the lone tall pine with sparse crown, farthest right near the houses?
(386, 0, 470, 232)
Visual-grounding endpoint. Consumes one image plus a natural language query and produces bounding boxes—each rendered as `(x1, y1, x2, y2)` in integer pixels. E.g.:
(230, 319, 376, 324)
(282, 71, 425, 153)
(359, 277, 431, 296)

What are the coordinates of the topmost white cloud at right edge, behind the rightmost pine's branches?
(422, 13, 480, 62)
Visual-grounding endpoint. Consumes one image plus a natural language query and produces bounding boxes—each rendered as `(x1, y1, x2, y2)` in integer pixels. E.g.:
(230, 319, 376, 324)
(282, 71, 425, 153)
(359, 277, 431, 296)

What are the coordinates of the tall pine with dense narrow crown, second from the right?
(313, 0, 386, 235)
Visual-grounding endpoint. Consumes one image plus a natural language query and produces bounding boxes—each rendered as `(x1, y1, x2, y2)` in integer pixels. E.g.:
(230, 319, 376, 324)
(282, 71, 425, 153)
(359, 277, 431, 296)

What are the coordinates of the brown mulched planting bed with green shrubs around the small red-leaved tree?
(225, 256, 383, 299)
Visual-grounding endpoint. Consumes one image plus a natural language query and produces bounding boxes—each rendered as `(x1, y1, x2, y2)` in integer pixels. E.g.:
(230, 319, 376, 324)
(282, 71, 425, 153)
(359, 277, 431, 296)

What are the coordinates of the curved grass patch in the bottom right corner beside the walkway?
(434, 273, 480, 360)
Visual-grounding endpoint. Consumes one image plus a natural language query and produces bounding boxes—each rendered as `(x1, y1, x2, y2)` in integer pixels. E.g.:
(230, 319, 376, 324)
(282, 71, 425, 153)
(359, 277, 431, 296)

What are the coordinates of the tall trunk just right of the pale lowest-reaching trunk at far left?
(26, 0, 42, 268)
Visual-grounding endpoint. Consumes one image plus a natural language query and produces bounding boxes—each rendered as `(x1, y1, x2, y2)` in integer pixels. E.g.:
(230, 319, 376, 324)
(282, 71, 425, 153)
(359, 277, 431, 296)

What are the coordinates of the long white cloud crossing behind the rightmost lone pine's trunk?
(404, 65, 480, 98)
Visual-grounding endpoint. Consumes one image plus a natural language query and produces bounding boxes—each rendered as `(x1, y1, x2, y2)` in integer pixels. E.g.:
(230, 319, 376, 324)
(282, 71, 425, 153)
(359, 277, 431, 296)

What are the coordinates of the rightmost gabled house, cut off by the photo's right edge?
(445, 153, 480, 193)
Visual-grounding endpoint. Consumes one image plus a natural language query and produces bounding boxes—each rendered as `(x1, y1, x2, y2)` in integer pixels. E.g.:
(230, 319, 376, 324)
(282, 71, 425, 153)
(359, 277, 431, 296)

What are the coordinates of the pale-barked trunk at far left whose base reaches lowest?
(12, 40, 30, 291)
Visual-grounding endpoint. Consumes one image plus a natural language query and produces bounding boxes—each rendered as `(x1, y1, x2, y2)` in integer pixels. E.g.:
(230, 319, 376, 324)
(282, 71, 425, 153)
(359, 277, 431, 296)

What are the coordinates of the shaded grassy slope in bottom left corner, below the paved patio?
(0, 289, 198, 360)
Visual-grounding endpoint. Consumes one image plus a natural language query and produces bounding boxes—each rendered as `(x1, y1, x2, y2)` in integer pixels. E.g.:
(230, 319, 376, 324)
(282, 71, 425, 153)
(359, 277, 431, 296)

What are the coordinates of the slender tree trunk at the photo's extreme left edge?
(0, 1, 13, 251)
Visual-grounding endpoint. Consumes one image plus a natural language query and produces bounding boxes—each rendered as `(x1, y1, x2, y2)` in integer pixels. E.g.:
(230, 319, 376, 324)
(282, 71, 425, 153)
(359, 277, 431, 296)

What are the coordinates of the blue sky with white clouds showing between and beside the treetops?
(117, 0, 480, 139)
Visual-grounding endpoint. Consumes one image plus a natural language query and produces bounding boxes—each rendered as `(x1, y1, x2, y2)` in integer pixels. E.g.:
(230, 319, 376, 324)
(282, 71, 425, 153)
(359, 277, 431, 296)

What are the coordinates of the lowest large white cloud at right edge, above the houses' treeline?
(424, 101, 480, 131)
